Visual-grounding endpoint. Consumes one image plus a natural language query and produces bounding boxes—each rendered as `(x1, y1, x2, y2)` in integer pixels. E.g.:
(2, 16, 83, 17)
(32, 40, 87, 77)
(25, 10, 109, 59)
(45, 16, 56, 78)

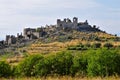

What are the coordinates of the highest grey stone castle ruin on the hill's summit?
(57, 17, 93, 31)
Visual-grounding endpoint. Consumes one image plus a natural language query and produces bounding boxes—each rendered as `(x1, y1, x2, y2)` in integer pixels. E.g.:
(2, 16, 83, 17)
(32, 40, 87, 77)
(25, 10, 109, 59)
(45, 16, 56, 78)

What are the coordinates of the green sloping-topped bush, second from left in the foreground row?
(16, 55, 43, 76)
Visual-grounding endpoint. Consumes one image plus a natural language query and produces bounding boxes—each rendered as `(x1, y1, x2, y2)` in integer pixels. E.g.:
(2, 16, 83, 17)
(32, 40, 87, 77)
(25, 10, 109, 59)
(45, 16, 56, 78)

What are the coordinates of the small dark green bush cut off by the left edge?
(0, 61, 11, 77)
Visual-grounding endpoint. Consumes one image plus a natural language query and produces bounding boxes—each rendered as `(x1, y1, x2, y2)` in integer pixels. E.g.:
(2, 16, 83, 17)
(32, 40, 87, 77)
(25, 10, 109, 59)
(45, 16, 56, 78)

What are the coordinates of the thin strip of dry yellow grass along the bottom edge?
(0, 76, 120, 80)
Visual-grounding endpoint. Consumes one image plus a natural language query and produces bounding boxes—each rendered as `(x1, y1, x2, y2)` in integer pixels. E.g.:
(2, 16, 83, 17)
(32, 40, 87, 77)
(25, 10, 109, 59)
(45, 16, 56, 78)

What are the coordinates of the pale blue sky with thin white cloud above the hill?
(0, 0, 120, 39)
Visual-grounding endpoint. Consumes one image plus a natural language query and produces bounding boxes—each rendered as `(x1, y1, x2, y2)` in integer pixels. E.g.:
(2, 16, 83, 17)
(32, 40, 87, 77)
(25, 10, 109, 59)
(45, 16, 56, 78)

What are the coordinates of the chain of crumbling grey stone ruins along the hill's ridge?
(0, 17, 98, 45)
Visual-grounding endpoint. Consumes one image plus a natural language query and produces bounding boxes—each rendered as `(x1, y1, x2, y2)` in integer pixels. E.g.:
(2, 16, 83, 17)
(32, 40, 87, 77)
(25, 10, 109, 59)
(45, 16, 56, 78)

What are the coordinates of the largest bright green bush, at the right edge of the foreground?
(87, 50, 120, 77)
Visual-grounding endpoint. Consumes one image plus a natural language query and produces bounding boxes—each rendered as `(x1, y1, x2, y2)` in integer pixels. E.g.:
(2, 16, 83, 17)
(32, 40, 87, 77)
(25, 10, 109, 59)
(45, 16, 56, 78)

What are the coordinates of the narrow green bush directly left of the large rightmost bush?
(71, 53, 87, 76)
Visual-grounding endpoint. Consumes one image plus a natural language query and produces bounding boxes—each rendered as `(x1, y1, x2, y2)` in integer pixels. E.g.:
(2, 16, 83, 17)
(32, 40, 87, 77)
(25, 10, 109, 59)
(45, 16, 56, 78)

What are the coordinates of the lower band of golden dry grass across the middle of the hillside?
(27, 39, 120, 54)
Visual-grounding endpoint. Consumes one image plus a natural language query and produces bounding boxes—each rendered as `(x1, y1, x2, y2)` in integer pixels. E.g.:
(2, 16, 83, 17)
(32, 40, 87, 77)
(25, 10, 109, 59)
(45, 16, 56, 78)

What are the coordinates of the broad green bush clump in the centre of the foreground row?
(36, 52, 73, 76)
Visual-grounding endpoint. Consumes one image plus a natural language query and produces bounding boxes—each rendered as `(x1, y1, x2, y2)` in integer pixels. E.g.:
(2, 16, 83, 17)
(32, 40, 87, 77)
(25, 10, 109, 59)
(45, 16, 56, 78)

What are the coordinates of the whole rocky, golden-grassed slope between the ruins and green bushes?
(0, 30, 120, 65)
